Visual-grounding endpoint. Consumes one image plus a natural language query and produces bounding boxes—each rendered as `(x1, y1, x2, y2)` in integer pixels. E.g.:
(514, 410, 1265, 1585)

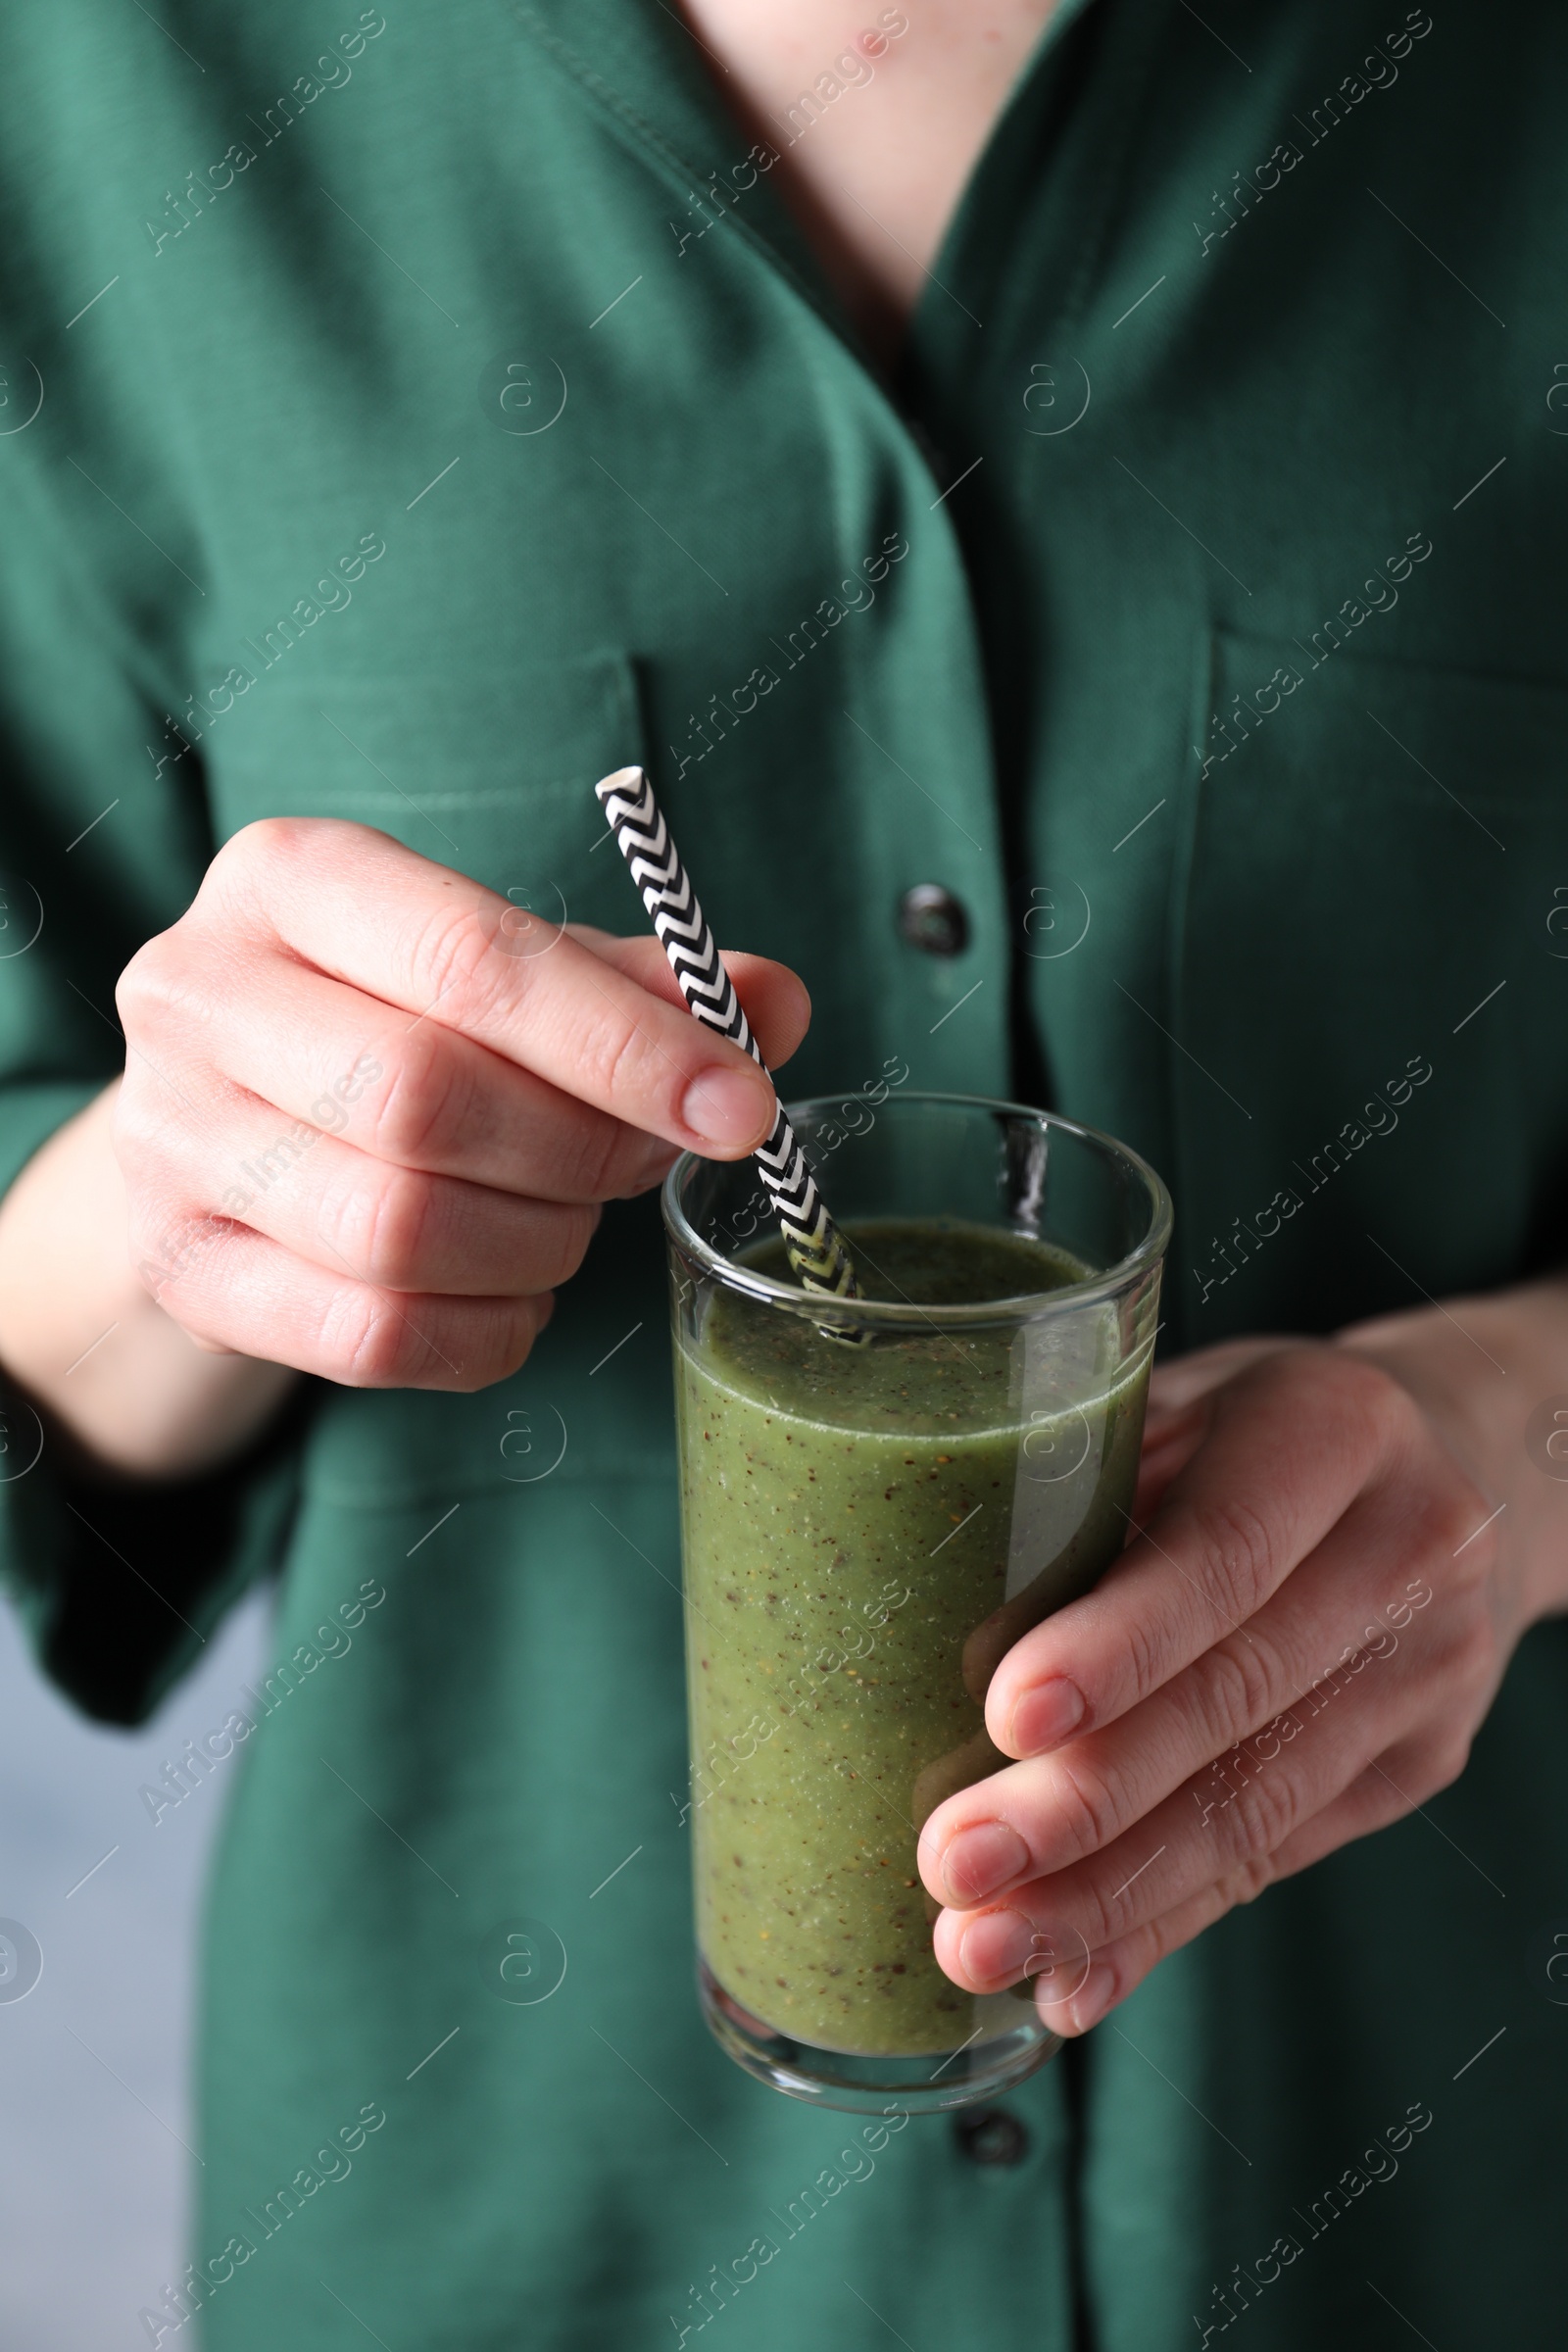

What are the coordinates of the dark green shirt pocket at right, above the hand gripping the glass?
(1168, 633, 1568, 1346)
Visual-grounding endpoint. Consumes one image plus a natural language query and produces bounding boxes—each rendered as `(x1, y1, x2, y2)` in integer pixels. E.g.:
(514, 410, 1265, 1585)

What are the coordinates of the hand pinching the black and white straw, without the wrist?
(116, 818, 808, 1390)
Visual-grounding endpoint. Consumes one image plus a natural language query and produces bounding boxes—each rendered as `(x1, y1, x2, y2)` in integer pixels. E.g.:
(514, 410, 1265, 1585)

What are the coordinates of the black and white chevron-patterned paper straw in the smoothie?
(595, 766, 860, 1339)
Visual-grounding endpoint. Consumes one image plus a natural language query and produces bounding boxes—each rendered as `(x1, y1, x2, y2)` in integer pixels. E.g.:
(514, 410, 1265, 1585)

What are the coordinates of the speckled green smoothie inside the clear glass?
(679, 1218, 1148, 2056)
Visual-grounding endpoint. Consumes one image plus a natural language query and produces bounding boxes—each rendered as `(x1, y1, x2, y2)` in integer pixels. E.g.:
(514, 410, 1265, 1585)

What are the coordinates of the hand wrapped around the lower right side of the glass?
(919, 1294, 1566, 2034)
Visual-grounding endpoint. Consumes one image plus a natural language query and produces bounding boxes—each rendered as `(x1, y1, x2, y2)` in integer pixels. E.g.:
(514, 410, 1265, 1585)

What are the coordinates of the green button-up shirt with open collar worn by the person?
(0, 0, 1568, 2352)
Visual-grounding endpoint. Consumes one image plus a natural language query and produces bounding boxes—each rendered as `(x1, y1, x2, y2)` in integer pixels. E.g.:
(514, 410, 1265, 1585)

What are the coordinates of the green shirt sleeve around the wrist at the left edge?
(0, 432, 308, 1724)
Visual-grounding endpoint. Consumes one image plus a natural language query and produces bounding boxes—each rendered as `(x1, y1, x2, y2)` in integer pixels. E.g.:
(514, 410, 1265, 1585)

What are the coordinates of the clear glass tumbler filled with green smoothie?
(662, 1080, 1171, 2112)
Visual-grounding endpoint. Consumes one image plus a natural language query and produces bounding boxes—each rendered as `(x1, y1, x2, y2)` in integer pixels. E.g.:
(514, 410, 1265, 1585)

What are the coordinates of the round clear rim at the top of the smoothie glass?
(659, 1089, 1175, 1331)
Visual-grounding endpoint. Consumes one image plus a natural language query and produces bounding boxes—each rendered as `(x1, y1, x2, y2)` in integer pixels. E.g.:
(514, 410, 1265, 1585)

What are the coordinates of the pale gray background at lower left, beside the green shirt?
(0, 1594, 270, 2352)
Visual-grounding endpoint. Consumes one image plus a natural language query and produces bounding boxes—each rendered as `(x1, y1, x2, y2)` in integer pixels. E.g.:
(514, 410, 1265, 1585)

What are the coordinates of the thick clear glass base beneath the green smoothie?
(696, 1952, 1062, 2115)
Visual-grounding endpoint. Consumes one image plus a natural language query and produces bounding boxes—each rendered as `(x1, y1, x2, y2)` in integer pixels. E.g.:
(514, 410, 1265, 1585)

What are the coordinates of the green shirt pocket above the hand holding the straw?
(209, 649, 647, 931)
